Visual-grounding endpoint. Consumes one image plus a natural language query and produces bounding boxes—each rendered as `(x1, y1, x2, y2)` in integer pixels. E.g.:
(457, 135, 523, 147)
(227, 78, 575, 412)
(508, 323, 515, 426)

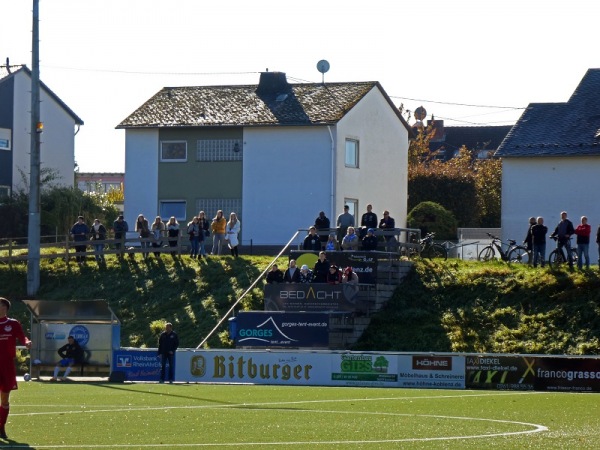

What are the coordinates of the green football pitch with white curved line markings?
(0, 382, 600, 449)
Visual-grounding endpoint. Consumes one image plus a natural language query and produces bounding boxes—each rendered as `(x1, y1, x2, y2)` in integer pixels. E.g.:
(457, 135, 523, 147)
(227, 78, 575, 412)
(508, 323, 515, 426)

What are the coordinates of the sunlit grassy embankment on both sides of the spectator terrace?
(0, 255, 600, 355)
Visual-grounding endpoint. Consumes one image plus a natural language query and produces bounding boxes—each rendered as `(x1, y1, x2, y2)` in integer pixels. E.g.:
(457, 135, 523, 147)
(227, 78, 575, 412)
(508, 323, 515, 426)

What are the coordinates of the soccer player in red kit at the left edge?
(0, 297, 31, 439)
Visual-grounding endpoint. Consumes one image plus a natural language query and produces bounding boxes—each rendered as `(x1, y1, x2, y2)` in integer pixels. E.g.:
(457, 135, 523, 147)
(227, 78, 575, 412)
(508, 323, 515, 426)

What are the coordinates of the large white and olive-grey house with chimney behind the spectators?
(117, 72, 411, 245)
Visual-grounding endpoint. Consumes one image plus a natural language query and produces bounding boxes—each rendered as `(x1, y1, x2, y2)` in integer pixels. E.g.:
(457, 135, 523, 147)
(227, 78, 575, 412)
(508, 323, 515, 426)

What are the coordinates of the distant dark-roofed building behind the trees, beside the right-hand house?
(427, 119, 512, 161)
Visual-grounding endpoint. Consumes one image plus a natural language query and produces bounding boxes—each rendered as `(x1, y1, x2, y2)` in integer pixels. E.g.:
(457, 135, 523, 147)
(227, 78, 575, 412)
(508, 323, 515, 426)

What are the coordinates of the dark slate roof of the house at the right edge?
(496, 69, 600, 158)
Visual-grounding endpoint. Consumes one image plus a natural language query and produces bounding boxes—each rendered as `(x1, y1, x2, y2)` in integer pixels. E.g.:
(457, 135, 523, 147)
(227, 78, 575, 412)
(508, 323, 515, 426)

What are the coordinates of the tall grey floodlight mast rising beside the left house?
(27, 0, 43, 296)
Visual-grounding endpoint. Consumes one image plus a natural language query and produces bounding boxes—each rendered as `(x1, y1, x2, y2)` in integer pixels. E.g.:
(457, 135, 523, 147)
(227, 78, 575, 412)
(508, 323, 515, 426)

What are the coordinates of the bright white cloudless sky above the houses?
(0, 0, 600, 172)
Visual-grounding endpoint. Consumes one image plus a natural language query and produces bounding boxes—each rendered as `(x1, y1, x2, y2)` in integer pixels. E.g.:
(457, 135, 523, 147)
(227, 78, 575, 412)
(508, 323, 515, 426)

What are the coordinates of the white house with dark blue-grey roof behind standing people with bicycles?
(496, 69, 600, 263)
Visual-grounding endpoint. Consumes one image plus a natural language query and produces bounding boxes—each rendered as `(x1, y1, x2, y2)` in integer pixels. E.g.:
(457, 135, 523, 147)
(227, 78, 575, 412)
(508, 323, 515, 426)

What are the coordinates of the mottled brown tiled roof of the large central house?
(117, 82, 400, 128)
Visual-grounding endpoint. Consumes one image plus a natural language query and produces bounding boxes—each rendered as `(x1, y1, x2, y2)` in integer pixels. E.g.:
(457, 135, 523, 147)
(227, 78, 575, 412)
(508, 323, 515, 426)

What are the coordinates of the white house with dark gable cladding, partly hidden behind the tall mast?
(0, 65, 83, 194)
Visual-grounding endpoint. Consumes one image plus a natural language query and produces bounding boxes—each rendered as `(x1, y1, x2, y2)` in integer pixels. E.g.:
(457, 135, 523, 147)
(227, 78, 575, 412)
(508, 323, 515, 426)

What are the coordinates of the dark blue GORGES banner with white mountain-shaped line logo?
(234, 311, 329, 348)
